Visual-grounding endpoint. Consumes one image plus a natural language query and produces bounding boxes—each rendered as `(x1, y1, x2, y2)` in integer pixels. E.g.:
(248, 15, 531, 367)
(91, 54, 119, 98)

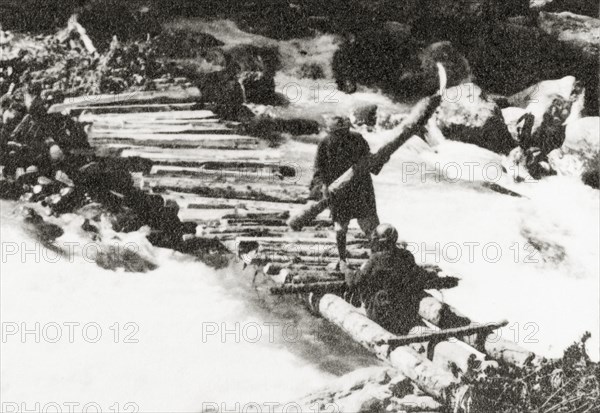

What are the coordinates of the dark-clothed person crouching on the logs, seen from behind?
(345, 224, 458, 335)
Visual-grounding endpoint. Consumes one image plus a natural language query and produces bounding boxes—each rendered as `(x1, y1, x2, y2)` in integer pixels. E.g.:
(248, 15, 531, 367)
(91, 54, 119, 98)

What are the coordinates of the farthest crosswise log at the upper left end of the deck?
(48, 87, 201, 113)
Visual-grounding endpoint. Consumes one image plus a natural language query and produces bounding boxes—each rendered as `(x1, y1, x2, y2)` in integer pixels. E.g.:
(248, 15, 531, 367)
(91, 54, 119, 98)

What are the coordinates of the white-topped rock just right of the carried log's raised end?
(435, 83, 517, 154)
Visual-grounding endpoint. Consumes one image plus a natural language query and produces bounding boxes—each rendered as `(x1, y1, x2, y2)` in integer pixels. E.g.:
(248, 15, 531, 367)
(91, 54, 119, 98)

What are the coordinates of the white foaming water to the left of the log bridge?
(0, 201, 375, 412)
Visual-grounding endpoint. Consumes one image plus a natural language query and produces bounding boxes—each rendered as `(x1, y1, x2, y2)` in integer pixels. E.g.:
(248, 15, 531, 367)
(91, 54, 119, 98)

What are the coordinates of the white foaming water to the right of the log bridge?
(369, 134, 600, 360)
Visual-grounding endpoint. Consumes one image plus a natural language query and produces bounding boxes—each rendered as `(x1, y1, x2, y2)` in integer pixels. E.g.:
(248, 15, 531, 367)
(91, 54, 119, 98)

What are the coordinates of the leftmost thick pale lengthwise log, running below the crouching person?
(319, 294, 458, 403)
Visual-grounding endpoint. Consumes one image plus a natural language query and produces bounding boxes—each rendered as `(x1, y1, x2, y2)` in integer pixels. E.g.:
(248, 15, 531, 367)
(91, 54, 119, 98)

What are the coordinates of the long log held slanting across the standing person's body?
(289, 95, 441, 231)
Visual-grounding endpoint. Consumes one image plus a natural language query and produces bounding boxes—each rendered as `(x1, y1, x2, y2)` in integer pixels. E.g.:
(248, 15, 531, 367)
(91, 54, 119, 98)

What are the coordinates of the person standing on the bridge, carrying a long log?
(313, 116, 379, 272)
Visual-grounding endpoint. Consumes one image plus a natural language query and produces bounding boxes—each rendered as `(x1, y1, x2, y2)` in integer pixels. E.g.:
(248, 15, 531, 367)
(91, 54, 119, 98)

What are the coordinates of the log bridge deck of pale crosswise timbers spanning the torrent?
(51, 91, 534, 406)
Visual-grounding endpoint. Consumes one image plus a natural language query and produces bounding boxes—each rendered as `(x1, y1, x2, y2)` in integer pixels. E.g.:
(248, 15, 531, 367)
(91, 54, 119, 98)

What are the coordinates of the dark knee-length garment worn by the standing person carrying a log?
(312, 131, 377, 222)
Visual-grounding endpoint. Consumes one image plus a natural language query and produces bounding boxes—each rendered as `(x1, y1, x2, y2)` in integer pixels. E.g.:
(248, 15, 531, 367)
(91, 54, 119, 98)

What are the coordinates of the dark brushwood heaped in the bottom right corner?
(454, 333, 600, 413)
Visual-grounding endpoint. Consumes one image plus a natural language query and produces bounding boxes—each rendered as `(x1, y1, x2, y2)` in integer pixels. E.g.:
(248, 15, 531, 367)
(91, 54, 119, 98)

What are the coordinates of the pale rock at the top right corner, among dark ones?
(538, 12, 600, 58)
